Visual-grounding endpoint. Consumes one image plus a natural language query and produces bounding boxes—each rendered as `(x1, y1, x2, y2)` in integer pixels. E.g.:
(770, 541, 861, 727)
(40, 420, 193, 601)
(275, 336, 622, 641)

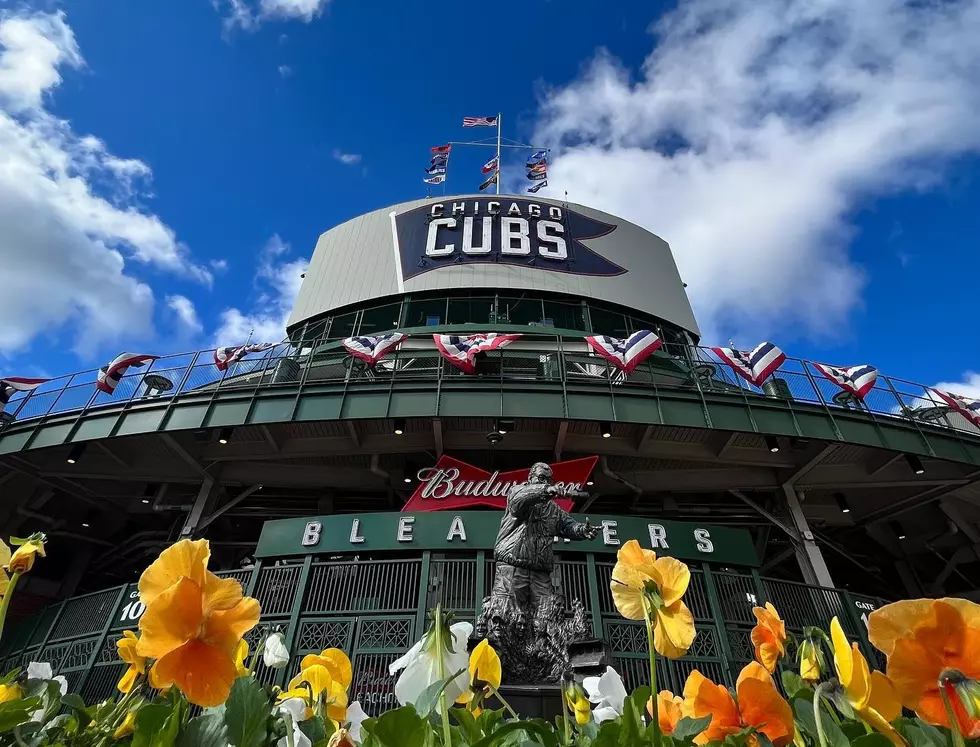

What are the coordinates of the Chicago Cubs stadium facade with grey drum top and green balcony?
(0, 195, 980, 708)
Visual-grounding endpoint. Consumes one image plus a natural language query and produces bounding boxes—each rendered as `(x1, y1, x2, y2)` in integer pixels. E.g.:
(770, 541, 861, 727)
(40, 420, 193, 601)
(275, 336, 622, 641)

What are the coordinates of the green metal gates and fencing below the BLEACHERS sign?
(0, 551, 883, 713)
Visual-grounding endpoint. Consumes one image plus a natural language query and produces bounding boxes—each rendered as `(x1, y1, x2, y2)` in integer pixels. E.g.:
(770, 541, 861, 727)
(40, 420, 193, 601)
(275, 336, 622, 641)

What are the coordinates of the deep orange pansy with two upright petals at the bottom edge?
(681, 661, 794, 747)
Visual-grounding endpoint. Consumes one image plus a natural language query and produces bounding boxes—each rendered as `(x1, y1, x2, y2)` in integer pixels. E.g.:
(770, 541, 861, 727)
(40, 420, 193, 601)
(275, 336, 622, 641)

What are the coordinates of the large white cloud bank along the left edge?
(0, 12, 211, 356)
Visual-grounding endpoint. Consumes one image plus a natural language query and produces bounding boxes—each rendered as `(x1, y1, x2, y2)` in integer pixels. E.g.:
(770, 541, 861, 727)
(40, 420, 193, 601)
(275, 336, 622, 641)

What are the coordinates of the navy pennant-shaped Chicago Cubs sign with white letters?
(395, 197, 626, 280)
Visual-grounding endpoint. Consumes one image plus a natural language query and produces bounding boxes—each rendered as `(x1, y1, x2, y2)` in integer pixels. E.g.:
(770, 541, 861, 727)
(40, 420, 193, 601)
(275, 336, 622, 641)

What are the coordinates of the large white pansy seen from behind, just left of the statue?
(389, 622, 473, 706)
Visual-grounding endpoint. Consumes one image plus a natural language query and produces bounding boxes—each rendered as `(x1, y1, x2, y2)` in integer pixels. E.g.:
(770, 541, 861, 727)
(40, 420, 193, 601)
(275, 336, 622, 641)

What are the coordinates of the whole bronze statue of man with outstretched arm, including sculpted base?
(476, 462, 599, 684)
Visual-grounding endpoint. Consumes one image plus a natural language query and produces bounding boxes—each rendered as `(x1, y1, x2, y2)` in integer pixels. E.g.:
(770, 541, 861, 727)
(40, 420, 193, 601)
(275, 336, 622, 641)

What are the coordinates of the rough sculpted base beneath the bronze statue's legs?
(475, 594, 592, 697)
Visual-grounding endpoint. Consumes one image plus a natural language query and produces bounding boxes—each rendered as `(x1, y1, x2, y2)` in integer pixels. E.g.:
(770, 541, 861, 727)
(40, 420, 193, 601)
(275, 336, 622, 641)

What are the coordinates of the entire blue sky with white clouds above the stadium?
(0, 0, 980, 395)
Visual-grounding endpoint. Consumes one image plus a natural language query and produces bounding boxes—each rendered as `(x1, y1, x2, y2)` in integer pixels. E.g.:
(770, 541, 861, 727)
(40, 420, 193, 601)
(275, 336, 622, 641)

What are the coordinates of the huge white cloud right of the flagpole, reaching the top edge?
(535, 0, 980, 339)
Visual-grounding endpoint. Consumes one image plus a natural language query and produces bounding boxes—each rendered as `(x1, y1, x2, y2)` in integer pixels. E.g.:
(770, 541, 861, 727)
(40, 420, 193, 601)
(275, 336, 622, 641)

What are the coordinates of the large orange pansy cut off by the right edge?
(868, 598, 980, 739)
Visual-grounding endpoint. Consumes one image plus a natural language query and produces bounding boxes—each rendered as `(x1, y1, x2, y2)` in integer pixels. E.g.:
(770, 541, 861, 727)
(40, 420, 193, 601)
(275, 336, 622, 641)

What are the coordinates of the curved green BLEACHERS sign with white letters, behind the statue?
(255, 511, 759, 566)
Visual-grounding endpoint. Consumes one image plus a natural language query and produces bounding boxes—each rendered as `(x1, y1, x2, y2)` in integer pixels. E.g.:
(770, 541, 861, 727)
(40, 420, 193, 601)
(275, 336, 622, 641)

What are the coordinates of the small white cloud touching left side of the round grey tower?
(214, 236, 309, 345)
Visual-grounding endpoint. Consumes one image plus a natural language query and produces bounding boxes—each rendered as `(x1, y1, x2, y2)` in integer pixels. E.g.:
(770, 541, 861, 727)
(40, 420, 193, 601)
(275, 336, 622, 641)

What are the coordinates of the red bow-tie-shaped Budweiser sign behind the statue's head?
(402, 455, 599, 511)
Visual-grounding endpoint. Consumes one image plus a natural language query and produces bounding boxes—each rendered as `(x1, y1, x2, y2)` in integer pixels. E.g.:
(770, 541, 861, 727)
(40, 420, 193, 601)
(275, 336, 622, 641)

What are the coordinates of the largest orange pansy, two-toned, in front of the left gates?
(136, 540, 259, 707)
